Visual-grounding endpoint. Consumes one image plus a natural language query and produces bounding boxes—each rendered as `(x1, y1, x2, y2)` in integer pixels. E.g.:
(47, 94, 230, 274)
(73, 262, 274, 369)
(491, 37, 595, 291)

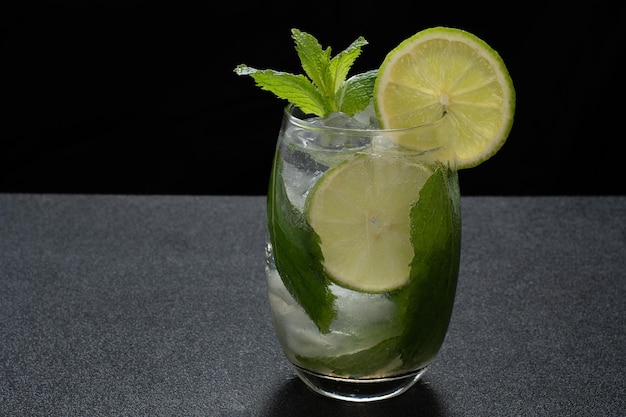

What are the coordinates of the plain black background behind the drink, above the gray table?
(0, 0, 626, 195)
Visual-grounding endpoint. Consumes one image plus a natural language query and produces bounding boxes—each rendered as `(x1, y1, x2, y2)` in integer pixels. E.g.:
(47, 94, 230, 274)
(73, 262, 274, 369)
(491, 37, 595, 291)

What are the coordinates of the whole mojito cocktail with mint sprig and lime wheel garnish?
(236, 28, 514, 401)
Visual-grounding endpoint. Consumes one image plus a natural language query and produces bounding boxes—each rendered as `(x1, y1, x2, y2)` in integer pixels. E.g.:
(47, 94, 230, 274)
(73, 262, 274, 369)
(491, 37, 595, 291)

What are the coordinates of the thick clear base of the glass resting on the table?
(293, 365, 428, 402)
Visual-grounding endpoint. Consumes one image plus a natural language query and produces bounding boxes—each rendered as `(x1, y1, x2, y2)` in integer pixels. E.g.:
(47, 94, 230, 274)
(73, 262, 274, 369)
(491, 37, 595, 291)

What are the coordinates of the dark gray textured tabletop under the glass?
(0, 194, 626, 417)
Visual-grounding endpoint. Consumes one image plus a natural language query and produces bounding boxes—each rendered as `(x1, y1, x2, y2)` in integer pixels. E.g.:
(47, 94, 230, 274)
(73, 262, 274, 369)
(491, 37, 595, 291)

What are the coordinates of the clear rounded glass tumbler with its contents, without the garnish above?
(266, 106, 461, 402)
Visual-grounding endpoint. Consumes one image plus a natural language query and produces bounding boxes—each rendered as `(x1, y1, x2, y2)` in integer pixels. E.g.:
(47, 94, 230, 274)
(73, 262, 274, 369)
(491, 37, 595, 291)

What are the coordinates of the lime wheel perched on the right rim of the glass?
(374, 27, 515, 169)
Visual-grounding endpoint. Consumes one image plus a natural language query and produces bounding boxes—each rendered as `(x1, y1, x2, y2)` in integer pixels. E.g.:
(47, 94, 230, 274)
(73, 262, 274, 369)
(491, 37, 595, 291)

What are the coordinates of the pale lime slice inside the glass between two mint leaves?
(305, 154, 432, 293)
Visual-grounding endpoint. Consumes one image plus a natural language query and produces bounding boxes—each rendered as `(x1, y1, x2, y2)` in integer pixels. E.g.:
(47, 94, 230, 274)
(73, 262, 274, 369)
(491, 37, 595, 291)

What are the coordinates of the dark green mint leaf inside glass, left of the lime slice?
(267, 151, 336, 333)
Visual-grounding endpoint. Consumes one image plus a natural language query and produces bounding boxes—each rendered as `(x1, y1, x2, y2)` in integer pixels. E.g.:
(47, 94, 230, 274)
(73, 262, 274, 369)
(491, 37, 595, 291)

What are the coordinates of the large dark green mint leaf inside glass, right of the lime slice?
(393, 167, 461, 367)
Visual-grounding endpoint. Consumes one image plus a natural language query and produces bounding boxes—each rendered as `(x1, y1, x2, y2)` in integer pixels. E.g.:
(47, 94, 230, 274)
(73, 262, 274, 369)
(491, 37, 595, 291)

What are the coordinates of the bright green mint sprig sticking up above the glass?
(234, 29, 370, 117)
